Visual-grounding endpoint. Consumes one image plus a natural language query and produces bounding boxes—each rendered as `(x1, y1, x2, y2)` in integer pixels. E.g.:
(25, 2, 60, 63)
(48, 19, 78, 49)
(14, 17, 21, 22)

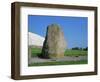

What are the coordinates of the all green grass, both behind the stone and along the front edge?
(29, 48, 87, 66)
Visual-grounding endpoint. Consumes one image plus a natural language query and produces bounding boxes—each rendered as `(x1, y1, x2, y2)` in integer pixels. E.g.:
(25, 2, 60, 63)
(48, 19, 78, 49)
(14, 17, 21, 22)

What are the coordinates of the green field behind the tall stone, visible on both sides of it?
(32, 48, 87, 57)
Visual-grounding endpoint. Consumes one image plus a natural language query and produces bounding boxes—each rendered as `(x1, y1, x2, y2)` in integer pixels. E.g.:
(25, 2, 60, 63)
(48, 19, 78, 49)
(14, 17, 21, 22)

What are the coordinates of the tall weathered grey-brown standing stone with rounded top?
(42, 24, 66, 58)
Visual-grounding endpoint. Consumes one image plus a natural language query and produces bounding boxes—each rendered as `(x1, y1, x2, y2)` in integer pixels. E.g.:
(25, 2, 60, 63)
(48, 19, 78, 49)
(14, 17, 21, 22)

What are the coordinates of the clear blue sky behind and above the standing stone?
(28, 15, 88, 48)
